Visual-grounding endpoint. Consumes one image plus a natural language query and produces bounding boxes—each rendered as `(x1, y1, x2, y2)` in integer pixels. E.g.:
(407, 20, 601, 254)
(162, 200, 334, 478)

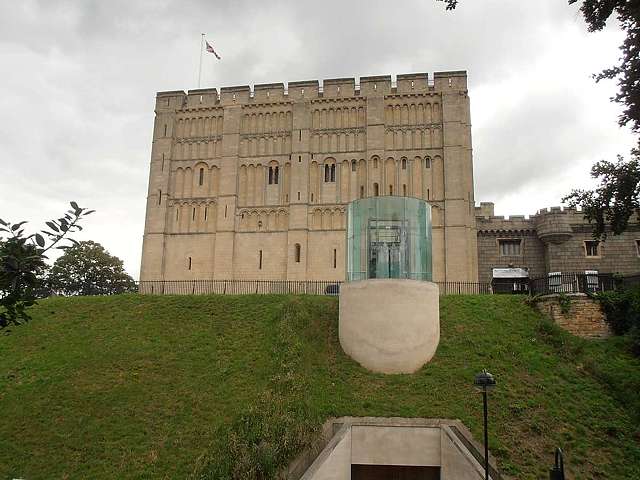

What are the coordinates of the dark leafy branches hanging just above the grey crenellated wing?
(562, 150, 640, 239)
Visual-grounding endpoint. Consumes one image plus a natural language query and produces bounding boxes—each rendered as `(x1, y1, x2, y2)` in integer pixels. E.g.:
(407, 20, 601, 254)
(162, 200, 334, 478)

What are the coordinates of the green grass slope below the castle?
(0, 295, 640, 479)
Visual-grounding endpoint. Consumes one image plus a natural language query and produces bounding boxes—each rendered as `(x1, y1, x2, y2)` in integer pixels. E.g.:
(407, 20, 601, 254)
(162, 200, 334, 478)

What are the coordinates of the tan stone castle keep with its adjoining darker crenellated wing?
(140, 71, 640, 282)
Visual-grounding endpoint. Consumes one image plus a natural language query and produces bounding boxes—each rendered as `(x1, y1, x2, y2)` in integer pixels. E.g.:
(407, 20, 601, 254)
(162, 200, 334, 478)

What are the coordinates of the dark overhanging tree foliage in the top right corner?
(436, 0, 640, 144)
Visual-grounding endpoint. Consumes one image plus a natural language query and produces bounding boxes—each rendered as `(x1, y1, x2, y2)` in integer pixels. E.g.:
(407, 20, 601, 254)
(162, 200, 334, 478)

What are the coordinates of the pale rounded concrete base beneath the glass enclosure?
(338, 279, 440, 373)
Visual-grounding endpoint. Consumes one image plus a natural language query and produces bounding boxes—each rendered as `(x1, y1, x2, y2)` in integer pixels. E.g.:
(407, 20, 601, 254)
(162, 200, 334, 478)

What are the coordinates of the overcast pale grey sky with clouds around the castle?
(0, 0, 633, 278)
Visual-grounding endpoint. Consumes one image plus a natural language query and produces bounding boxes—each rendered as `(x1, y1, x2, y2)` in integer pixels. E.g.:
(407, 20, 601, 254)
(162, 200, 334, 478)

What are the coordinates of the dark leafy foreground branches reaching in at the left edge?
(0, 202, 94, 329)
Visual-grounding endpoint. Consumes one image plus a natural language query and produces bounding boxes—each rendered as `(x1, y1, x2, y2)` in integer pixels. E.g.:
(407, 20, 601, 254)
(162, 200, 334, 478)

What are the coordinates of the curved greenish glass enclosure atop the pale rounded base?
(347, 196, 432, 282)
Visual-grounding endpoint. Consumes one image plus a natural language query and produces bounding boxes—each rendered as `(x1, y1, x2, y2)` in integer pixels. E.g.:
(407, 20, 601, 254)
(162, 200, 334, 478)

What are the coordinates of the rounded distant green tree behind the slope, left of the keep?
(49, 241, 136, 295)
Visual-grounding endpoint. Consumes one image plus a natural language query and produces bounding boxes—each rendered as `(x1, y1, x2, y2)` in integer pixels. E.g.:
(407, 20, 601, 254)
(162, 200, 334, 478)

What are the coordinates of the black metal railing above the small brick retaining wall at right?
(529, 272, 618, 295)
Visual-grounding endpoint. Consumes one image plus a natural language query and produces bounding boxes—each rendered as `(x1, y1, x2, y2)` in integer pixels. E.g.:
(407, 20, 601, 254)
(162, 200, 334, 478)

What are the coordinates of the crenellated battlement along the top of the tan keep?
(156, 71, 467, 111)
